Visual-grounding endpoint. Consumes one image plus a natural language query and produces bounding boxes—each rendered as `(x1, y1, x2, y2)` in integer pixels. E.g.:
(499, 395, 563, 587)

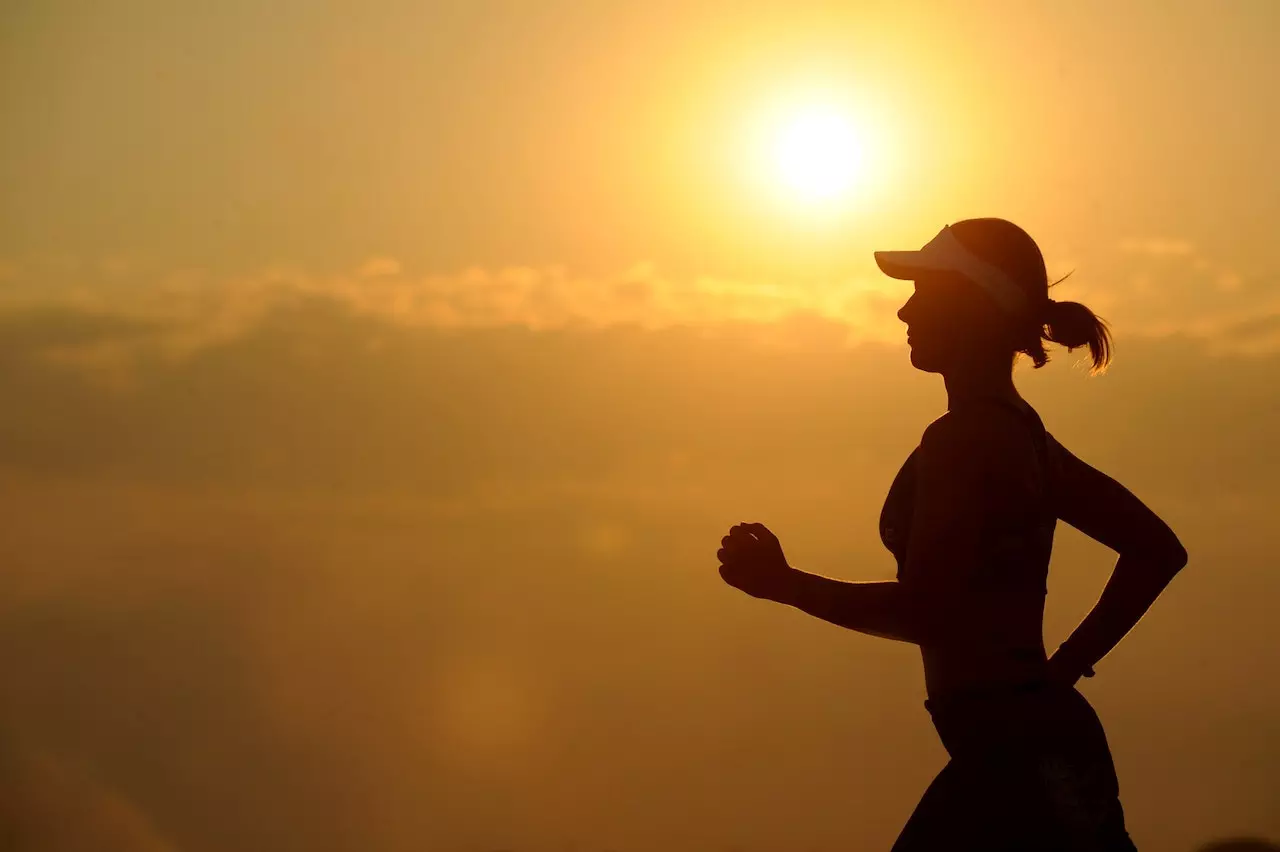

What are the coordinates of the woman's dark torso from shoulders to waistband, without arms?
(879, 402, 1057, 697)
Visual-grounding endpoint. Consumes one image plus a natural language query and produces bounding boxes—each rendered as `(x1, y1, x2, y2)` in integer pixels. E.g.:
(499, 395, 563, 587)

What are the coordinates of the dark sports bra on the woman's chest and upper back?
(879, 399, 1057, 583)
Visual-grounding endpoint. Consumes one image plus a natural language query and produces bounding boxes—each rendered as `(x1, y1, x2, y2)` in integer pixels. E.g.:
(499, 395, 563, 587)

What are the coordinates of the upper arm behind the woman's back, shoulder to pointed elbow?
(1053, 441, 1181, 553)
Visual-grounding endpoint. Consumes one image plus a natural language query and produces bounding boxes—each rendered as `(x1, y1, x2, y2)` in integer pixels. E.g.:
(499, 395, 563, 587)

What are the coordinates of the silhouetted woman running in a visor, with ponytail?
(718, 219, 1187, 852)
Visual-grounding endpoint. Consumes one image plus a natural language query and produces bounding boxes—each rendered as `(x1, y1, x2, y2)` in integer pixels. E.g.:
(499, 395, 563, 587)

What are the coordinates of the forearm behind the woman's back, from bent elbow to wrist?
(1055, 550, 1187, 673)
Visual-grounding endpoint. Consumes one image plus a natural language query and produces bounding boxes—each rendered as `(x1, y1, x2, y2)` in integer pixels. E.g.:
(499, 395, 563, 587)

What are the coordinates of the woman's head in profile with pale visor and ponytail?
(876, 219, 1111, 372)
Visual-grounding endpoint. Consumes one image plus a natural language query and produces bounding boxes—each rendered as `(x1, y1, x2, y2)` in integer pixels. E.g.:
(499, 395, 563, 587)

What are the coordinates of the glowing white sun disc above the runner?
(771, 107, 865, 203)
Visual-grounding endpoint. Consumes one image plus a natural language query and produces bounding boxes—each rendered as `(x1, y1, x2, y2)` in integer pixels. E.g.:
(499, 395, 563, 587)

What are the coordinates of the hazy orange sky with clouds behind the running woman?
(0, 0, 1280, 852)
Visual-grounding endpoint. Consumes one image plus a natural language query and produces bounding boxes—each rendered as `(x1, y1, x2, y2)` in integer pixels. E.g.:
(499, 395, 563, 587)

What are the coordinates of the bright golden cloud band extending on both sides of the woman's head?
(0, 239, 1280, 378)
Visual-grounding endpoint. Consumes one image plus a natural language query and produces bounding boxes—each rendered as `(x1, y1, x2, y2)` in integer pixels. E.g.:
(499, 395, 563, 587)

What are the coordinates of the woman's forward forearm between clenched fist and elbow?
(776, 568, 916, 642)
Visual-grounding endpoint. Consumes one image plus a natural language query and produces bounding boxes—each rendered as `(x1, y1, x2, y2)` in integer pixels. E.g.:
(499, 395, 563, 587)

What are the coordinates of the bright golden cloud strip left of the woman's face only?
(0, 257, 905, 365)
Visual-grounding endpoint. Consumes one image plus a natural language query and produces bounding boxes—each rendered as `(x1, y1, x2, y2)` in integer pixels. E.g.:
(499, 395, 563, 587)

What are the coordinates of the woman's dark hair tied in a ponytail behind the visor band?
(951, 219, 1112, 375)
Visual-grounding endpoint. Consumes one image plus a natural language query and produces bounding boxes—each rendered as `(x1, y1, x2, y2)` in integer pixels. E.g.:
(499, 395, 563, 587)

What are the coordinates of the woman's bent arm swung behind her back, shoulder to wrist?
(1052, 441, 1187, 674)
